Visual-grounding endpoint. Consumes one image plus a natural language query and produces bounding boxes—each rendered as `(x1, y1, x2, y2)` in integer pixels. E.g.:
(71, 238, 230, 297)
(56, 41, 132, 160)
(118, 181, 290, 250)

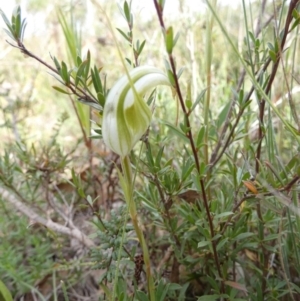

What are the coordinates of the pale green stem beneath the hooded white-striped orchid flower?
(121, 156, 155, 301)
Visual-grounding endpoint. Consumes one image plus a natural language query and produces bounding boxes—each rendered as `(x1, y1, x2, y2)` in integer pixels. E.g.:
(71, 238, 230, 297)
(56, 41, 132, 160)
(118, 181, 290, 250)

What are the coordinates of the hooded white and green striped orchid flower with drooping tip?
(102, 66, 170, 157)
